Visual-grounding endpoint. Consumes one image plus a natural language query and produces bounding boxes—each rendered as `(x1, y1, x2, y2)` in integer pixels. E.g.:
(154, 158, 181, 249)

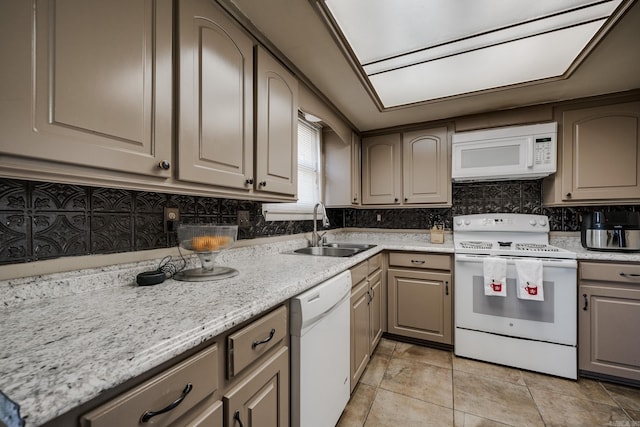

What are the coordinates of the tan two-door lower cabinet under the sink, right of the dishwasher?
(351, 254, 386, 391)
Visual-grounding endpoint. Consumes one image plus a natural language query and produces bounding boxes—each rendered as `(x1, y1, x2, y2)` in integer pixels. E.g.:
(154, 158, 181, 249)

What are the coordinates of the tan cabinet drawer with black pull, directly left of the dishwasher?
(227, 306, 288, 378)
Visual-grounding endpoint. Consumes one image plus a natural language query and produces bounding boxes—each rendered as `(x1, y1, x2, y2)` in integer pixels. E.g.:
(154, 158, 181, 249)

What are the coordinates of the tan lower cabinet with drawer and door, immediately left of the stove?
(387, 252, 453, 345)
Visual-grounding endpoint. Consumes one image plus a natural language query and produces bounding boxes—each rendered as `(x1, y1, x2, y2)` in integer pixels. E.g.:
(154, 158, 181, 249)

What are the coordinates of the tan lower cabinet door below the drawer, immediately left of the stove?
(387, 269, 452, 344)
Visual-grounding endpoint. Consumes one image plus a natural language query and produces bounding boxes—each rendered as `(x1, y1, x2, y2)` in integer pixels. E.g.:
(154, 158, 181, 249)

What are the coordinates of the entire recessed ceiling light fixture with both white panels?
(324, 0, 622, 108)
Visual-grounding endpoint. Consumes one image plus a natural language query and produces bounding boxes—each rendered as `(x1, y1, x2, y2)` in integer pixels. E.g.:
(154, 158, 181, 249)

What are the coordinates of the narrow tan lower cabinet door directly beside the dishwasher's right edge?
(351, 279, 370, 391)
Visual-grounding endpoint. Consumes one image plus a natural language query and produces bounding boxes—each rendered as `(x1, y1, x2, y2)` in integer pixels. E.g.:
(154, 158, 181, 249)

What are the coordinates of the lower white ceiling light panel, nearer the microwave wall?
(369, 22, 601, 107)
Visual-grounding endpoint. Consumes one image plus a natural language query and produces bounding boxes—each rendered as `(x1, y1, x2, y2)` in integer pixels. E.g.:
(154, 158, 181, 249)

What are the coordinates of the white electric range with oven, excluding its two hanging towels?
(453, 213, 577, 379)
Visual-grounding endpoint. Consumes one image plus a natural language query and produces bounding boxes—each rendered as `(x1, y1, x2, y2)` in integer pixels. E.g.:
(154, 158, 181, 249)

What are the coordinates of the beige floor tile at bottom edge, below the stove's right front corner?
(531, 389, 630, 427)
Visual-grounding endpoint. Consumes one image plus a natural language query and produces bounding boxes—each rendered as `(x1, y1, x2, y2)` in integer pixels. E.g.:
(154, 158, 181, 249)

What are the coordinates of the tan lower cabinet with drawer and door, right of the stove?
(578, 262, 640, 381)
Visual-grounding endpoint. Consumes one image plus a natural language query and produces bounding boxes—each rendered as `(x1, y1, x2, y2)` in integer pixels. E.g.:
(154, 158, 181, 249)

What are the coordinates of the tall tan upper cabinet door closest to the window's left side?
(256, 47, 298, 196)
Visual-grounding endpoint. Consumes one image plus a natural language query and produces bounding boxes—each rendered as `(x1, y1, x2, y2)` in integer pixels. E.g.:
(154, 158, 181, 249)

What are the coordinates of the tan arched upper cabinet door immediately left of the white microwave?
(402, 127, 451, 204)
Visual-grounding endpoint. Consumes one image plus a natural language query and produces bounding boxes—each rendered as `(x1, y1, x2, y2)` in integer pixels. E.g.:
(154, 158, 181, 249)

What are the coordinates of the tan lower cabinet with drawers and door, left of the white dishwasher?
(81, 305, 289, 427)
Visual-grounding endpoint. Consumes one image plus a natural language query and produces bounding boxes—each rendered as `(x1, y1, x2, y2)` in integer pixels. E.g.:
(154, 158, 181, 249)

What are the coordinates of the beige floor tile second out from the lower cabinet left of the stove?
(380, 357, 453, 408)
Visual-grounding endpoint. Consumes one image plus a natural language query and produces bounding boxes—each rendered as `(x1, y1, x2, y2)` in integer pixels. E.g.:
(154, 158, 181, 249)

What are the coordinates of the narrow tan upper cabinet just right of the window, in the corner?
(322, 130, 361, 207)
